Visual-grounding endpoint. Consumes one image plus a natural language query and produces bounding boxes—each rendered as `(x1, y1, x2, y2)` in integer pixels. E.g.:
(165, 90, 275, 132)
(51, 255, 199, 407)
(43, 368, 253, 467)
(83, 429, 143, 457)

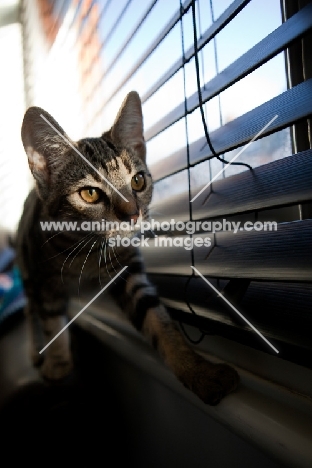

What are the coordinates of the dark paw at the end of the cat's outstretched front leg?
(181, 358, 239, 405)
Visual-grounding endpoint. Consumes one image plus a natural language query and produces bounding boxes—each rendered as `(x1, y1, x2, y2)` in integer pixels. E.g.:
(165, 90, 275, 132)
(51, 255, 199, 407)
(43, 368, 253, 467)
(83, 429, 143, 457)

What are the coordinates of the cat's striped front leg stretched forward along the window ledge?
(111, 255, 239, 405)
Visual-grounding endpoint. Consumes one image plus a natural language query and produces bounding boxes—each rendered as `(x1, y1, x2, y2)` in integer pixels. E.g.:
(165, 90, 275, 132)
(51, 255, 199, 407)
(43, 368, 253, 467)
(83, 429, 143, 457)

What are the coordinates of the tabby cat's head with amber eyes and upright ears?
(22, 92, 152, 237)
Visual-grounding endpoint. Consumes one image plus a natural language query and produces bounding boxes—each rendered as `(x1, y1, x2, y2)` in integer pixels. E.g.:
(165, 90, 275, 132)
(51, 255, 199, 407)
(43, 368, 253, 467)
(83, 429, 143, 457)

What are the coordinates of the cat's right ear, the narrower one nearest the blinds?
(110, 91, 146, 160)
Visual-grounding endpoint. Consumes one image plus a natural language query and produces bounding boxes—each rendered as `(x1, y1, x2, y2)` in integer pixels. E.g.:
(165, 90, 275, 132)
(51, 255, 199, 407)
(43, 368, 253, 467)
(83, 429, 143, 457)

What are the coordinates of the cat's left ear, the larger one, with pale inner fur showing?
(21, 107, 73, 194)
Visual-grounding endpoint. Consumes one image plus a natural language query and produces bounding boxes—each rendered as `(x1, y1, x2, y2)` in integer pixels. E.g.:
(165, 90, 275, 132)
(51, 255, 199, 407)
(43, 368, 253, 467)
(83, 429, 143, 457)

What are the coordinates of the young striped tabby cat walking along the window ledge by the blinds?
(16, 91, 239, 405)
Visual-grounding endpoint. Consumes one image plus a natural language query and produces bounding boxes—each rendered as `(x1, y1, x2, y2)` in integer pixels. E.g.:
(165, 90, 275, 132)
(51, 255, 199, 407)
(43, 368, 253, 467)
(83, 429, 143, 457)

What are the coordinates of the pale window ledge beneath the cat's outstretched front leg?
(70, 298, 312, 468)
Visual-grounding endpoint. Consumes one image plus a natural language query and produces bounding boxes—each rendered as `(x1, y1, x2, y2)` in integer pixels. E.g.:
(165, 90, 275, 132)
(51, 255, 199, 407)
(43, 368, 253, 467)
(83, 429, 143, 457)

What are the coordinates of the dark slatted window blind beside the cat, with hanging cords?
(23, 0, 312, 367)
